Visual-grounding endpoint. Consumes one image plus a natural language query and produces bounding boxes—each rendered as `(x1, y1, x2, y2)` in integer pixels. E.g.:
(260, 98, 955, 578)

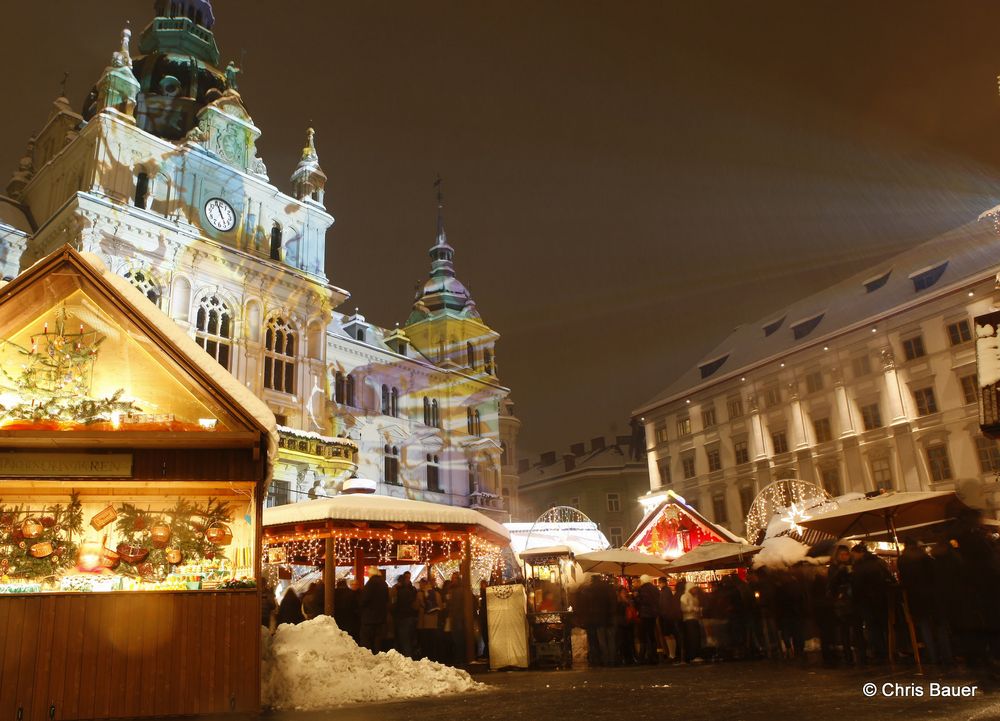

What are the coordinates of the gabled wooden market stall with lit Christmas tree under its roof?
(0, 247, 276, 721)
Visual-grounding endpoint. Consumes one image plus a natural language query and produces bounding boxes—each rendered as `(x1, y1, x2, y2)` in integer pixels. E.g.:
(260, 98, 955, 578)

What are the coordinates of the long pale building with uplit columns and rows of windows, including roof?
(635, 217, 1000, 533)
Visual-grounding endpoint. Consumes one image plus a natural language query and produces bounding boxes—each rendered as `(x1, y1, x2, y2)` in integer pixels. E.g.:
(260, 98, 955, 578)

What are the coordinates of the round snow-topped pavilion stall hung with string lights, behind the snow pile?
(263, 493, 510, 660)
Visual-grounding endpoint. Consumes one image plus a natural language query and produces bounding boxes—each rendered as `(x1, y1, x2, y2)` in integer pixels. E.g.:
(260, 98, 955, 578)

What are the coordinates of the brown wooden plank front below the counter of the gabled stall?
(0, 590, 260, 721)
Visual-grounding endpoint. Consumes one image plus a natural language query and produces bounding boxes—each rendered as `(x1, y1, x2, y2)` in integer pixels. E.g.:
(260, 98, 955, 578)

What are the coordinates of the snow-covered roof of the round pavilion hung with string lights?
(264, 494, 510, 540)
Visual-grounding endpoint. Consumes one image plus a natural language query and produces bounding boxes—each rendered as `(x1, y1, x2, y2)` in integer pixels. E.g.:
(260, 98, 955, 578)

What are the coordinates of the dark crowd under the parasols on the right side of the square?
(573, 524, 1000, 667)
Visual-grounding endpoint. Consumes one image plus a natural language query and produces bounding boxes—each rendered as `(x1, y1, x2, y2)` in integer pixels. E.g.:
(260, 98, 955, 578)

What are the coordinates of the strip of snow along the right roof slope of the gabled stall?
(79, 253, 278, 464)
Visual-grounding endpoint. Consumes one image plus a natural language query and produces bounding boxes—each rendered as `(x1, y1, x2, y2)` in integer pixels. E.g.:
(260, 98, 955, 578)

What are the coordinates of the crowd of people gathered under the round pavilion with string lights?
(261, 570, 489, 665)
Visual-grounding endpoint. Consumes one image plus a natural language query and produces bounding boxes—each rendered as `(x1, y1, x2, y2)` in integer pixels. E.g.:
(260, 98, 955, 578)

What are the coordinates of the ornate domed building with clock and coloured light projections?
(0, 0, 519, 520)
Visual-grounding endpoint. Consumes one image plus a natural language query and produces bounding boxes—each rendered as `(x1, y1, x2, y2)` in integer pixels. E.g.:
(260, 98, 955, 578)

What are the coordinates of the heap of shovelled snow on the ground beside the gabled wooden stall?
(261, 616, 486, 711)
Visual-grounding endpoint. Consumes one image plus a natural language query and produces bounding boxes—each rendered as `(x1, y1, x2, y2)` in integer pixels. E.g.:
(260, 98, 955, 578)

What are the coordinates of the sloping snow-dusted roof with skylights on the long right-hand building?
(636, 211, 1000, 414)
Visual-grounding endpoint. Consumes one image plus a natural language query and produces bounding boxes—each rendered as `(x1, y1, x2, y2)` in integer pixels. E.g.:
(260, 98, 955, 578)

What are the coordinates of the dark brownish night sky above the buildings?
(0, 0, 1000, 453)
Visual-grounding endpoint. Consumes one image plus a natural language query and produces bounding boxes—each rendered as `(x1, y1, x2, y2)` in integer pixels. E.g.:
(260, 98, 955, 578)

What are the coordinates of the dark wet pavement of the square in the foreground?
(266, 662, 1000, 721)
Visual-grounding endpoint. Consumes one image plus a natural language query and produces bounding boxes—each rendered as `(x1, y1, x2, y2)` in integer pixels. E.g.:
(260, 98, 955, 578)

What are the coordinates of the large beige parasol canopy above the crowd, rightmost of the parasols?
(798, 491, 968, 538)
